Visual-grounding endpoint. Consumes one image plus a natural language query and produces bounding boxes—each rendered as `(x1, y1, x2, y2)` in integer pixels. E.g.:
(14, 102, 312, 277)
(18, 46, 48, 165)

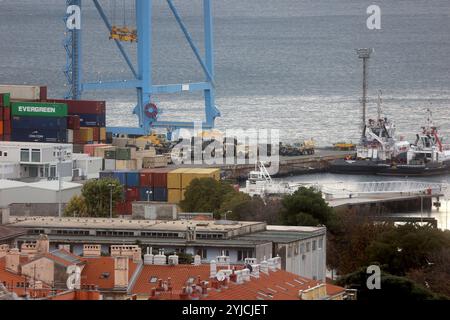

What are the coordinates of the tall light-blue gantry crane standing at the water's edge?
(64, 0, 220, 135)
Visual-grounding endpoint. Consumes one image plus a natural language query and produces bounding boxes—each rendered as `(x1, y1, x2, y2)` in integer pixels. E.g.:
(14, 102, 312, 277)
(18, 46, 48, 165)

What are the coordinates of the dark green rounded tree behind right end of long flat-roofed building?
(281, 187, 337, 230)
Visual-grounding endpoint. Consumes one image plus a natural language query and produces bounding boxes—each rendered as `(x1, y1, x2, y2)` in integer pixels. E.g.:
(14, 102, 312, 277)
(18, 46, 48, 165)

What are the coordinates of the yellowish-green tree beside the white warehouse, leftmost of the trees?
(64, 179, 123, 217)
